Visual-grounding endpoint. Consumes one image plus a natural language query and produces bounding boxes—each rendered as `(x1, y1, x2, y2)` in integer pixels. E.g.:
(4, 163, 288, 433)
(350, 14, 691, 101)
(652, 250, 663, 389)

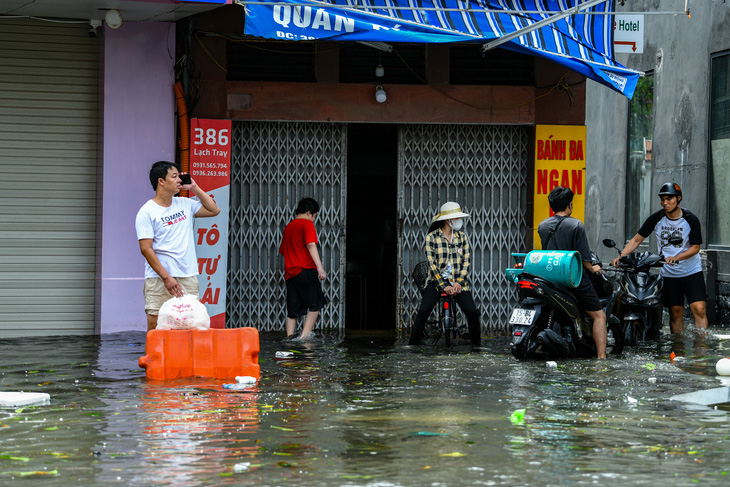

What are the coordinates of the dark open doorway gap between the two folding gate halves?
(345, 124, 398, 330)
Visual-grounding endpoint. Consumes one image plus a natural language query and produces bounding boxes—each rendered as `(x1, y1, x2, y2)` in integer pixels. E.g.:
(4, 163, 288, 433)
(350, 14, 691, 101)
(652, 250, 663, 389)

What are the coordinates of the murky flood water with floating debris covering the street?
(0, 333, 730, 486)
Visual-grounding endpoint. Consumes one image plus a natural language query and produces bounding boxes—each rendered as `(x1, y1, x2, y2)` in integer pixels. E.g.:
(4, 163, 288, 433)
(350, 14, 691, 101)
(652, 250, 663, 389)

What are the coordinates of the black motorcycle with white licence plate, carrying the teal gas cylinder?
(509, 254, 624, 360)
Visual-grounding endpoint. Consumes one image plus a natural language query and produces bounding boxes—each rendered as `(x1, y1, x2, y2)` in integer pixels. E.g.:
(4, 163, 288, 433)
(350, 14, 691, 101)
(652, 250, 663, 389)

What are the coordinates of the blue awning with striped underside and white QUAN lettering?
(239, 0, 639, 98)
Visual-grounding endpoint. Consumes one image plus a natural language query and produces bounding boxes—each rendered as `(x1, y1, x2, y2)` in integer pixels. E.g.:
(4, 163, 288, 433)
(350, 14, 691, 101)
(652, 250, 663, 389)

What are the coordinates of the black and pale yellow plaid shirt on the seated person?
(426, 228, 470, 291)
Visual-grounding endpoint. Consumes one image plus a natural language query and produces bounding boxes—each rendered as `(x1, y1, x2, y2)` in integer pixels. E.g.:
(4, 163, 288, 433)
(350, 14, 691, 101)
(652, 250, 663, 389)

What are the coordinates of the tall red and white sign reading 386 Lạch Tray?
(190, 118, 231, 328)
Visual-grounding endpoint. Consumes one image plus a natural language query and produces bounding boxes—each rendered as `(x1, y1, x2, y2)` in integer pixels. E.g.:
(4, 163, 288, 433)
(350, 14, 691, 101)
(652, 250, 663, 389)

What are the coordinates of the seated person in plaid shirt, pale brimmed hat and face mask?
(408, 202, 482, 347)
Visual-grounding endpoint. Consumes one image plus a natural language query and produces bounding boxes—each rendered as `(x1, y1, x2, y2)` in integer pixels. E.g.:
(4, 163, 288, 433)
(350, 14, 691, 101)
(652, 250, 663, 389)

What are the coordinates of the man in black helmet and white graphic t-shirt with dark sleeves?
(611, 182, 707, 333)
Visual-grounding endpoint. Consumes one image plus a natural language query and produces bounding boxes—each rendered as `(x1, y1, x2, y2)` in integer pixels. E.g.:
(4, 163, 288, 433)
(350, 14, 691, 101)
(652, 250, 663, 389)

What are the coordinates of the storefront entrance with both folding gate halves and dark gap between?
(226, 122, 528, 331)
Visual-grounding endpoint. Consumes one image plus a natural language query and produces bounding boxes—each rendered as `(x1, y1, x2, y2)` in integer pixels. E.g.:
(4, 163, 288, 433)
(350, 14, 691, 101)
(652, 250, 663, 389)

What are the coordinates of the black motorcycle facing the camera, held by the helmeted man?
(603, 235, 682, 345)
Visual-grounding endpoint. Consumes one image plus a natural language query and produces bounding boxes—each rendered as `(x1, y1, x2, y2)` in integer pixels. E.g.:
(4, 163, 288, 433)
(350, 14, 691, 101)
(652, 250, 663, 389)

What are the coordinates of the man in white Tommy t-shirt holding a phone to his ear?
(135, 161, 220, 330)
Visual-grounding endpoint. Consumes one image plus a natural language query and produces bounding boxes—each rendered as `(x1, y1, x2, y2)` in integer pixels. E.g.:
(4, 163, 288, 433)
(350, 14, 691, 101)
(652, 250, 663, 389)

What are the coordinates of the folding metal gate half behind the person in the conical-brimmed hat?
(398, 125, 528, 332)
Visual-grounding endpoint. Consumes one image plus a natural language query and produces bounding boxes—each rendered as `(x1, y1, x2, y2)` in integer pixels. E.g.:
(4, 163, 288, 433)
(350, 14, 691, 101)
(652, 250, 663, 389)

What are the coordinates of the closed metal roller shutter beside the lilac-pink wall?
(0, 19, 99, 337)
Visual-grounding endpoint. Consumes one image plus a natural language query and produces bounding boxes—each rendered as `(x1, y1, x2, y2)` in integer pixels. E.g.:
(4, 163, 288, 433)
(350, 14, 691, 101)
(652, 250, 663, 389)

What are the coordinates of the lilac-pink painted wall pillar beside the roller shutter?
(96, 22, 176, 333)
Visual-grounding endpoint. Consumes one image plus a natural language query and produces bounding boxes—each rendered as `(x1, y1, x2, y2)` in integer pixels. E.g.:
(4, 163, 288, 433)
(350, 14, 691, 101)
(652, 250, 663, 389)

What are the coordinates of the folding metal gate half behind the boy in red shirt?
(226, 122, 347, 331)
